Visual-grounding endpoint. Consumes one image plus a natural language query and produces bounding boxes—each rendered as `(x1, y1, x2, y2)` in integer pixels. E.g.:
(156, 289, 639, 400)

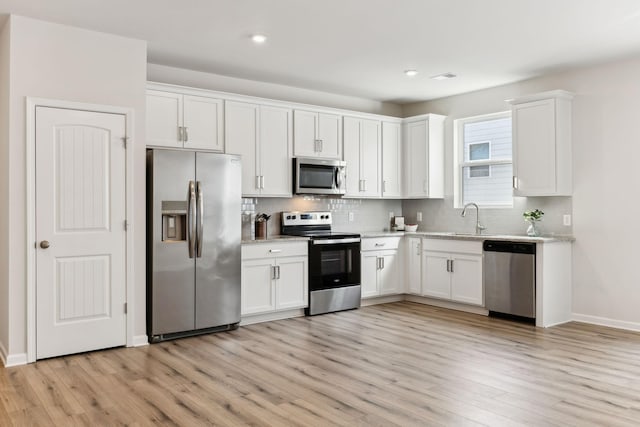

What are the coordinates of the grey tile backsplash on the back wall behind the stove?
(242, 195, 402, 240)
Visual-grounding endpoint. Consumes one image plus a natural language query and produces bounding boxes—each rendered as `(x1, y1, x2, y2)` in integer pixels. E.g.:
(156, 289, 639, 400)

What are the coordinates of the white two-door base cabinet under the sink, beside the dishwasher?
(422, 239, 484, 305)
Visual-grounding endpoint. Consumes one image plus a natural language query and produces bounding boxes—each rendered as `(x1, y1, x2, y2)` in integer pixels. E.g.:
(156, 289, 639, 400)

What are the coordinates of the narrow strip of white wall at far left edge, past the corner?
(0, 20, 10, 359)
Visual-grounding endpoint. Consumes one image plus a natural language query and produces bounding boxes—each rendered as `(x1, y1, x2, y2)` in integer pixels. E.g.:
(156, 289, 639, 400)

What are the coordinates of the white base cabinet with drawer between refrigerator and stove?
(241, 242, 308, 316)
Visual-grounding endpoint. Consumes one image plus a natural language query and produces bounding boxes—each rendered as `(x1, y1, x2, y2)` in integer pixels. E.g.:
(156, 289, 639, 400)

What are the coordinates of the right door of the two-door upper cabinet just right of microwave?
(360, 120, 382, 197)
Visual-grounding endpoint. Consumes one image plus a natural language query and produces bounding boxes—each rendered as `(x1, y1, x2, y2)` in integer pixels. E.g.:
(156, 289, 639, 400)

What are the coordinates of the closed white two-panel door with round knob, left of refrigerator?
(36, 107, 126, 359)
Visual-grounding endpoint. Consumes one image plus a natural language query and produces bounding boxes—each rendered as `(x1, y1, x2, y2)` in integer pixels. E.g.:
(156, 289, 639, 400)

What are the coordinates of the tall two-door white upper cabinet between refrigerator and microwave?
(225, 101, 292, 197)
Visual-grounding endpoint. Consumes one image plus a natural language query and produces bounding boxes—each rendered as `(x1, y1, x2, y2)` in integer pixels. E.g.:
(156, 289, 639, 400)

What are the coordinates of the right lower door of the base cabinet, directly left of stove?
(276, 257, 308, 310)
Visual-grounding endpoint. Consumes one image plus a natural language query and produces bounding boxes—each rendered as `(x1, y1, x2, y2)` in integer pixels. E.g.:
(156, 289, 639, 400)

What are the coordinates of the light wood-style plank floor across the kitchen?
(0, 302, 640, 426)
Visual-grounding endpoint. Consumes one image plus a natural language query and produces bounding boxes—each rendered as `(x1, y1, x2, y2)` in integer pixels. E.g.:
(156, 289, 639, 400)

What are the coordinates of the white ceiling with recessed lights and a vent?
(0, 0, 640, 103)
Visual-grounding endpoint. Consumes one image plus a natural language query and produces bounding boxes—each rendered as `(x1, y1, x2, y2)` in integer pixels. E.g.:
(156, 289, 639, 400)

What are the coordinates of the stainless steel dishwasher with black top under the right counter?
(483, 240, 536, 321)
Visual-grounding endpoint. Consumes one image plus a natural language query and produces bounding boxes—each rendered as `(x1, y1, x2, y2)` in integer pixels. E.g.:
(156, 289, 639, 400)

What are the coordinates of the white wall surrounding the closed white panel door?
(0, 16, 146, 364)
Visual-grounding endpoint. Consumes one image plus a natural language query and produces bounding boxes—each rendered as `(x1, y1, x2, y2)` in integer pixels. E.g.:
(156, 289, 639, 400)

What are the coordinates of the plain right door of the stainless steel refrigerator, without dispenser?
(195, 153, 241, 329)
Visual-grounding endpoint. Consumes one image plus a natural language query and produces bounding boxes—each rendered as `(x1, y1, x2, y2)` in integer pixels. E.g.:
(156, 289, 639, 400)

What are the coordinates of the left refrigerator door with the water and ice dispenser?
(147, 150, 195, 336)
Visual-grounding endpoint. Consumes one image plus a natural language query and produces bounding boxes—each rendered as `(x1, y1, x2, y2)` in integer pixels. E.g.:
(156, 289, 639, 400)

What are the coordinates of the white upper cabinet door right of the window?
(512, 99, 556, 196)
